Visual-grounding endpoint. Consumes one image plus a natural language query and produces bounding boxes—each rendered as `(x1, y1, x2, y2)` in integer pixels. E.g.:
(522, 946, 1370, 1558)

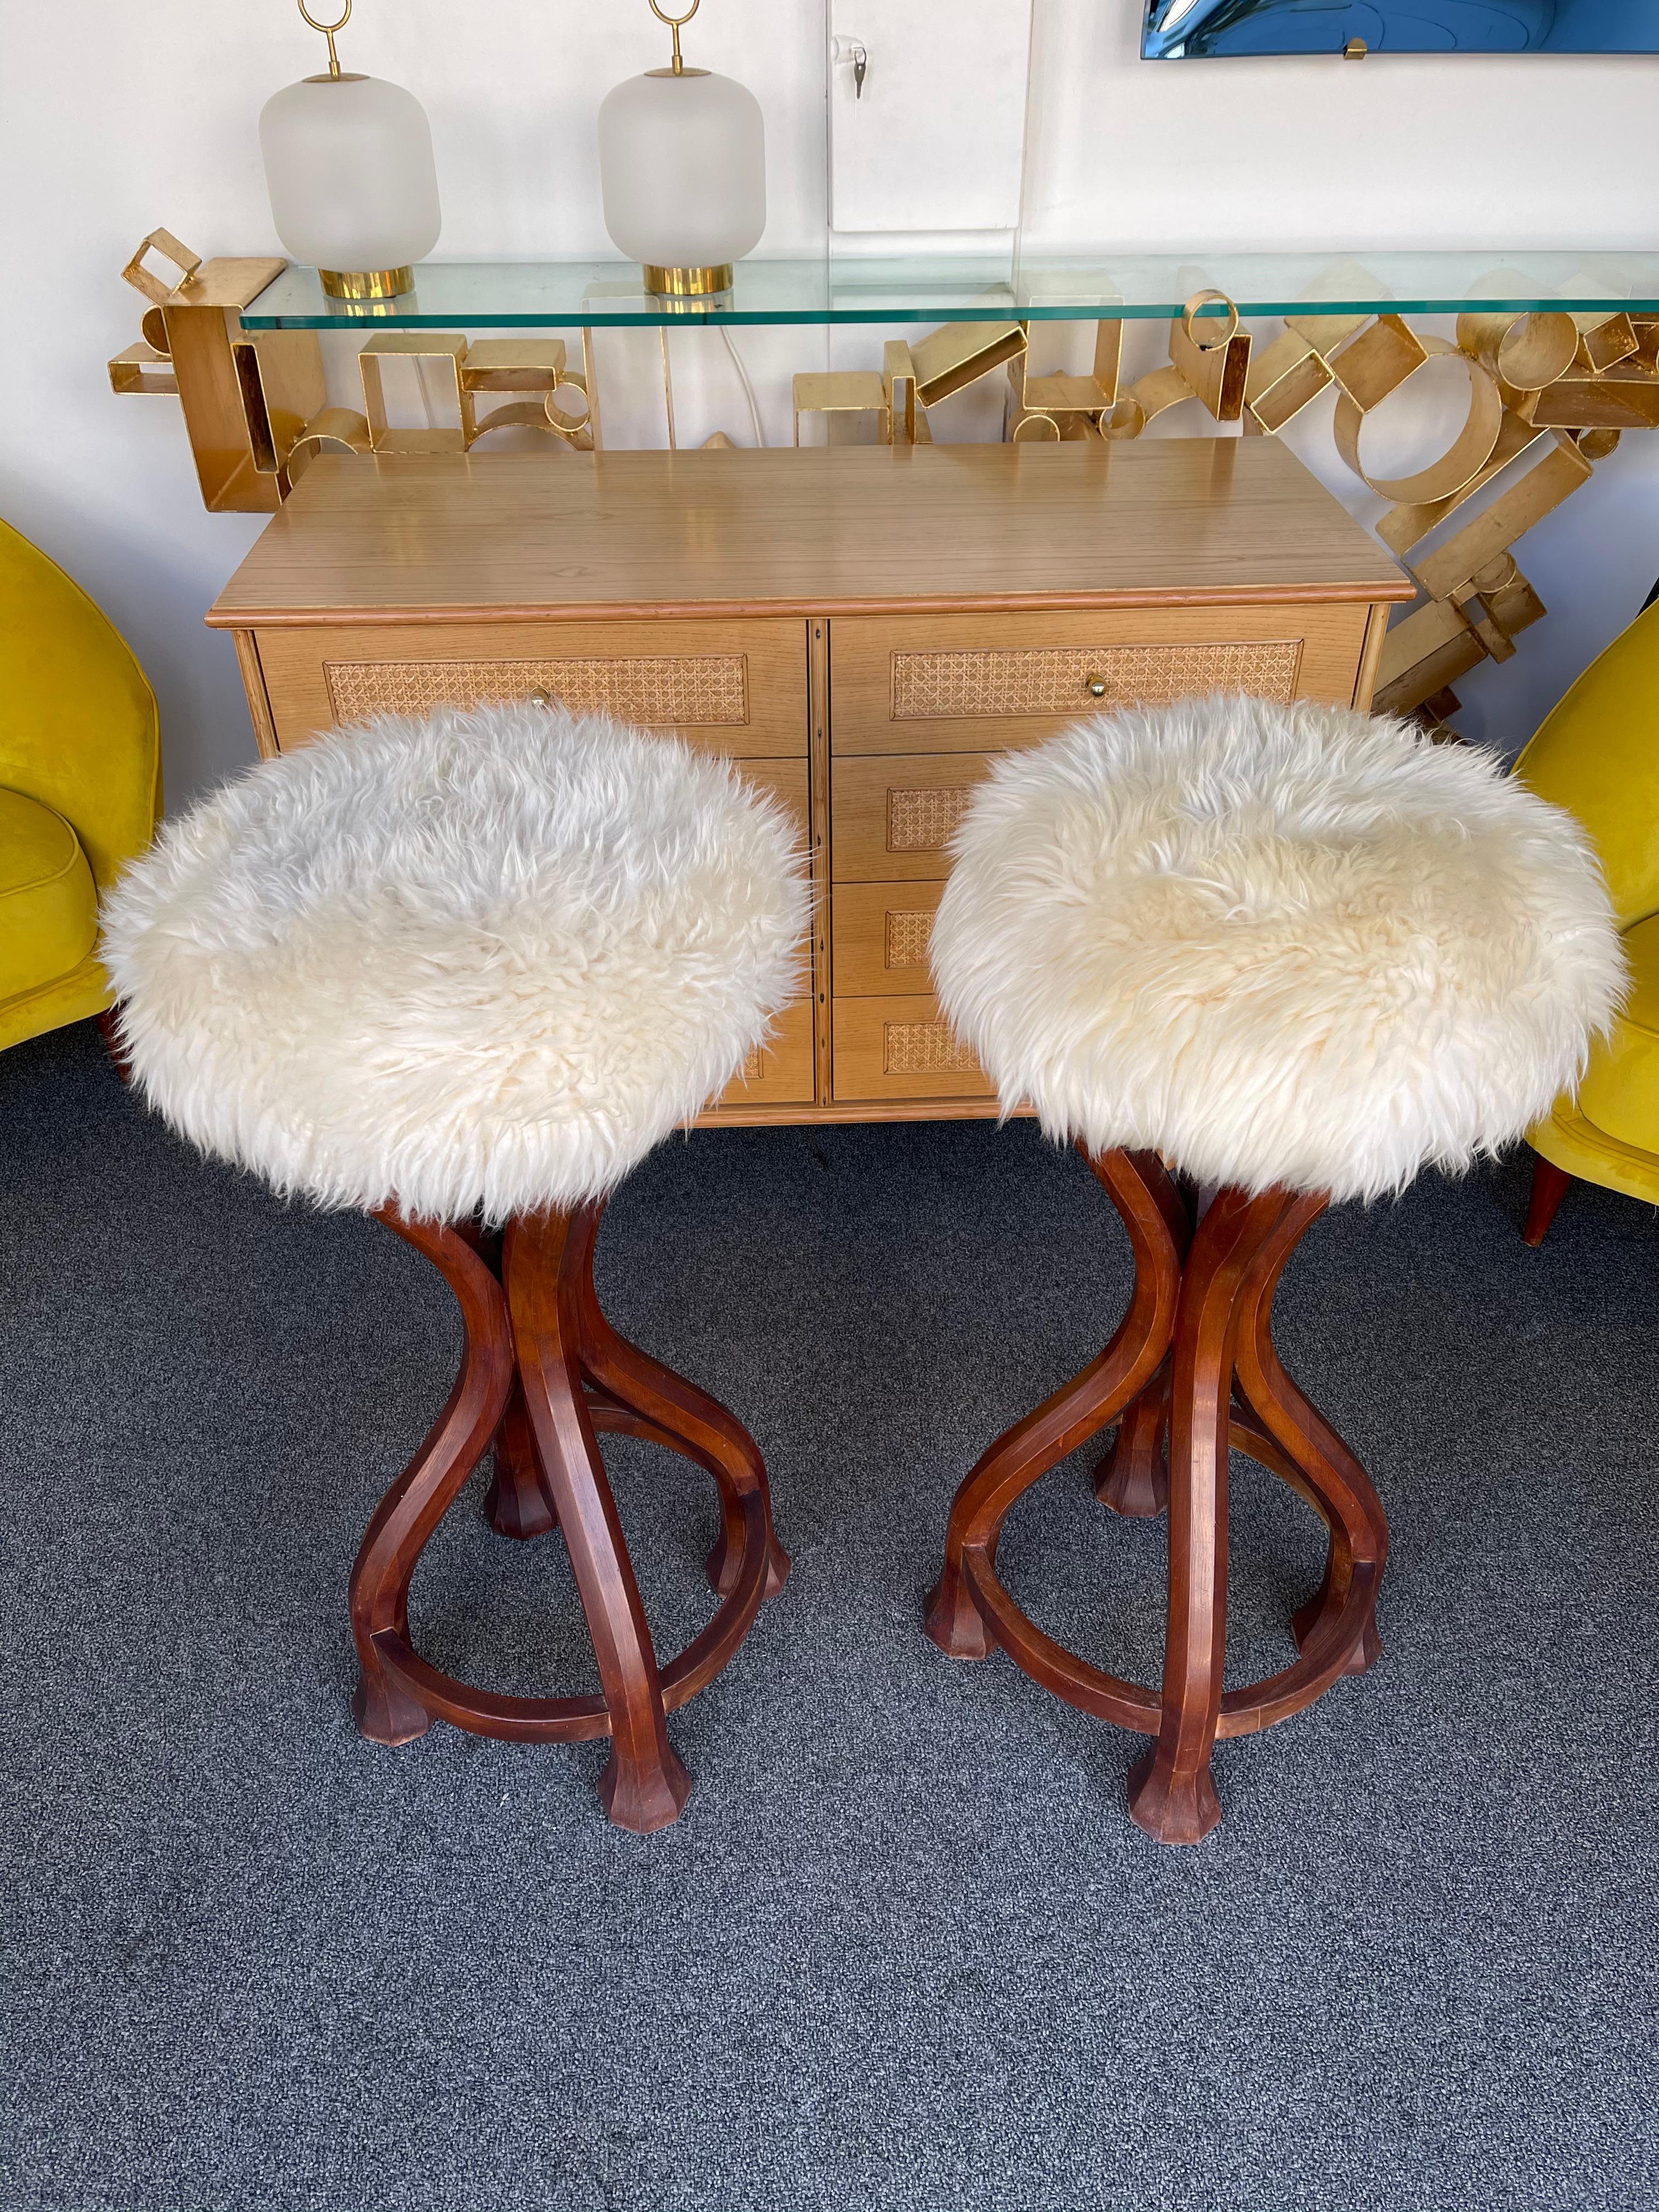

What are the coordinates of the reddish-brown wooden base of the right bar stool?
(927, 1153, 1389, 1843)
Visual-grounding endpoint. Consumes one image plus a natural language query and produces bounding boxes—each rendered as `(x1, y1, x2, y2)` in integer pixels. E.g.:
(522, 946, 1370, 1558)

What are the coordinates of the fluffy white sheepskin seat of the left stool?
(101, 706, 810, 1221)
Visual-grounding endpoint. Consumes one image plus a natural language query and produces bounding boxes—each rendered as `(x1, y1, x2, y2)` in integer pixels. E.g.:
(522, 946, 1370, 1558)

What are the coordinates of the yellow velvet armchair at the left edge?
(0, 522, 161, 1051)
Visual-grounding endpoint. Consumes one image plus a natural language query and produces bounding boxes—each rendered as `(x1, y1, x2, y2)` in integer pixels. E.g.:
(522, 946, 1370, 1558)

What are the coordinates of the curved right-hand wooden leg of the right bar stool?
(1234, 1194, 1389, 1674)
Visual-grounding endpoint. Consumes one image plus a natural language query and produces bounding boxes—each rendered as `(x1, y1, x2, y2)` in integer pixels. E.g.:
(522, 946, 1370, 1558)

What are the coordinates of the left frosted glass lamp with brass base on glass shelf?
(259, 75, 442, 298)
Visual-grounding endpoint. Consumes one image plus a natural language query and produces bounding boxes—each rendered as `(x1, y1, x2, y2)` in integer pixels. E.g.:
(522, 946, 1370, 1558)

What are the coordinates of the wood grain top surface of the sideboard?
(208, 438, 1413, 630)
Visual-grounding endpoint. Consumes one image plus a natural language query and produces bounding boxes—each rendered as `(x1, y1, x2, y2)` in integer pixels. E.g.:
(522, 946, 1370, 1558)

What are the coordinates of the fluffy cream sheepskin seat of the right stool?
(934, 699, 1623, 1197)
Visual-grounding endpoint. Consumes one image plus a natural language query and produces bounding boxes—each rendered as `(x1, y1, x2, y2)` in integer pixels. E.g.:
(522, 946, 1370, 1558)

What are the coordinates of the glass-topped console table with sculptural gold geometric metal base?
(111, 232, 1659, 728)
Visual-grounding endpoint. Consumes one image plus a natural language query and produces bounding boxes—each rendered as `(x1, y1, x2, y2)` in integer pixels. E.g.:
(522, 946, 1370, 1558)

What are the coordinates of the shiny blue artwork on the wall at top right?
(1142, 0, 1659, 62)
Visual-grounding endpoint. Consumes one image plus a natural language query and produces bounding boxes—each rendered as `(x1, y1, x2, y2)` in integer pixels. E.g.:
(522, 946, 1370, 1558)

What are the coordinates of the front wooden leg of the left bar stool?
(502, 1205, 692, 1834)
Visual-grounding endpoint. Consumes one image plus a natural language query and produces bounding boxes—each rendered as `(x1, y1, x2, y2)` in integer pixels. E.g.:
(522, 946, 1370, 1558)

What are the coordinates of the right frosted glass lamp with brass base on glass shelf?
(600, 69, 765, 292)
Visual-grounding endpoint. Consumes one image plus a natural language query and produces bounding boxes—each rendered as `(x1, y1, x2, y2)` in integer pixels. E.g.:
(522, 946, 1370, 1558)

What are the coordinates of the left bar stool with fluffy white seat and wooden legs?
(104, 703, 808, 1831)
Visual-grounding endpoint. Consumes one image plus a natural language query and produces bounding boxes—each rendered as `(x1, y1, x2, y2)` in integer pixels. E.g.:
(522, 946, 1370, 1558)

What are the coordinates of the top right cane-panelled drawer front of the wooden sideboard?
(830, 606, 1369, 754)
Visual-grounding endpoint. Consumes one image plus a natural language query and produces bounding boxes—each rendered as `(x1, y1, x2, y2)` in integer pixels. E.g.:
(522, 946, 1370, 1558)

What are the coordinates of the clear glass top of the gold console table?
(241, 248, 1659, 330)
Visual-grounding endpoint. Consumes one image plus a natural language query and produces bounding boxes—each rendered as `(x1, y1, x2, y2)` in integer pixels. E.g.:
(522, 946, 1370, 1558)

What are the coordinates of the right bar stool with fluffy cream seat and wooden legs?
(927, 699, 1623, 1843)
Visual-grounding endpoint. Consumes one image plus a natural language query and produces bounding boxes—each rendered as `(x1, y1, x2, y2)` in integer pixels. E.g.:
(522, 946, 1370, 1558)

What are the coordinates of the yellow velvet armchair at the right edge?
(1515, 606, 1659, 1245)
